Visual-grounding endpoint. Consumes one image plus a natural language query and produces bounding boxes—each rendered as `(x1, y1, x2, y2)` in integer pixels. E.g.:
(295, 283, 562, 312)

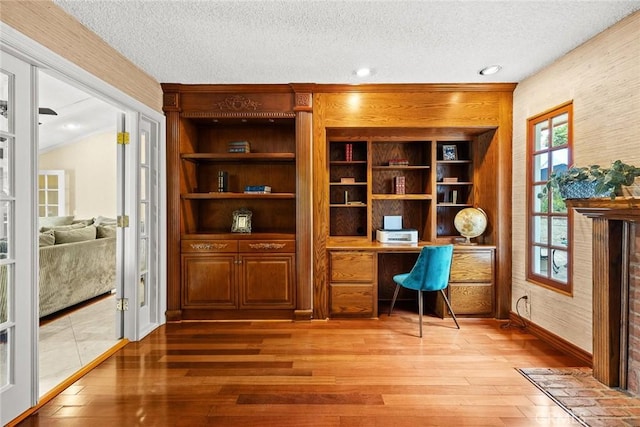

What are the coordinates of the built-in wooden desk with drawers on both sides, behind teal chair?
(327, 239, 495, 317)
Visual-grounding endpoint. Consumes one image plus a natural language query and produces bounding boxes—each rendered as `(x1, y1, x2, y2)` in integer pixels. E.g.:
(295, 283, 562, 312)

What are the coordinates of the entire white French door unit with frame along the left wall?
(0, 22, 166, 425)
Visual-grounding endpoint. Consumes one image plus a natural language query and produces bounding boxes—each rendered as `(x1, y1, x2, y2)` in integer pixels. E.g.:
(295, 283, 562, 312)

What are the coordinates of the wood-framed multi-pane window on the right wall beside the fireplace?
(527, 103, 573, 294)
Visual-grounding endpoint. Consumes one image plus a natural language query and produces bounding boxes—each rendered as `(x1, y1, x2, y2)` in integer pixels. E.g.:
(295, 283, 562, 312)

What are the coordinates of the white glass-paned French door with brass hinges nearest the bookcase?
(118, 114, 164, 341)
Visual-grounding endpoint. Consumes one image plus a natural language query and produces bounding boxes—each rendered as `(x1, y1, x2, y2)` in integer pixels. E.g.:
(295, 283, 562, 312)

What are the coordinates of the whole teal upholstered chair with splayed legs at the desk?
(389, 245, 460, 338)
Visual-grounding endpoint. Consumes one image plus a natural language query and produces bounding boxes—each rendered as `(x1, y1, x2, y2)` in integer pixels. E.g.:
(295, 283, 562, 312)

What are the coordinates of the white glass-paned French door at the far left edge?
(0, 52, 38, 425)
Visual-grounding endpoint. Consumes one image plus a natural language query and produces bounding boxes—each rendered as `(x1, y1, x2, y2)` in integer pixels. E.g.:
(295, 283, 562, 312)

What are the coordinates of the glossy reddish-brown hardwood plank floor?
(19, 307, 580, 427)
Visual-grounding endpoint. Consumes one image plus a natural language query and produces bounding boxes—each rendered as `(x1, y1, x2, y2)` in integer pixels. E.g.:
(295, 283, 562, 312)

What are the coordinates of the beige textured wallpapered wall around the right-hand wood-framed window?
(512, 12, 640, 352)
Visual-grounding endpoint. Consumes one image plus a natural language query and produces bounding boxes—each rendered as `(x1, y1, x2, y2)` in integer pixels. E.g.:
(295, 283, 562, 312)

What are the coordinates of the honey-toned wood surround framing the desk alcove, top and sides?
(313, 84, 514, 319)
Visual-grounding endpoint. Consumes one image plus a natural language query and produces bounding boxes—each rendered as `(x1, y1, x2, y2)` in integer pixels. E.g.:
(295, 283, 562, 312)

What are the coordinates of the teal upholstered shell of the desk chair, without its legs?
(402, 245, 453, 291)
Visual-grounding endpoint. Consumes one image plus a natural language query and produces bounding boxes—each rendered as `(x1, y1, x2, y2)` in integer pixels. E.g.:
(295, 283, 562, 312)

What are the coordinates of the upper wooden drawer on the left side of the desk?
(329, 251, 376, 283)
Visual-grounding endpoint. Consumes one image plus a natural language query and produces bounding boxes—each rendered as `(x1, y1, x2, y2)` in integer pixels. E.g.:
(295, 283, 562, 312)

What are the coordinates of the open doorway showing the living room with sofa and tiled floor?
(37, 70, 123, 396)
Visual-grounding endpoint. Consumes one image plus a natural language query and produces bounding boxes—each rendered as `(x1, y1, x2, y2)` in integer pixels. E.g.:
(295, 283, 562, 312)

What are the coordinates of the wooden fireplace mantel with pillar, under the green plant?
(566, 197, 640, 388)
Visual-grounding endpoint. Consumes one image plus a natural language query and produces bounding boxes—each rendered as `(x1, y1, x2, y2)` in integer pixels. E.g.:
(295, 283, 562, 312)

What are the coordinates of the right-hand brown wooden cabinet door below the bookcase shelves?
(240, 254, 295, 309)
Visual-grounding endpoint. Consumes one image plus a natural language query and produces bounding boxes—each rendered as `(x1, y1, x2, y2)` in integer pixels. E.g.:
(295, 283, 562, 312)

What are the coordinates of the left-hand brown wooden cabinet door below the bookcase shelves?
(182, 254, 238, 309)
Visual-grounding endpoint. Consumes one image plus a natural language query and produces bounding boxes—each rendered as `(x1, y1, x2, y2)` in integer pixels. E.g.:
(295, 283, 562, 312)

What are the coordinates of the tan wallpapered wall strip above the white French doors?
(0, 0, 162, 111)
